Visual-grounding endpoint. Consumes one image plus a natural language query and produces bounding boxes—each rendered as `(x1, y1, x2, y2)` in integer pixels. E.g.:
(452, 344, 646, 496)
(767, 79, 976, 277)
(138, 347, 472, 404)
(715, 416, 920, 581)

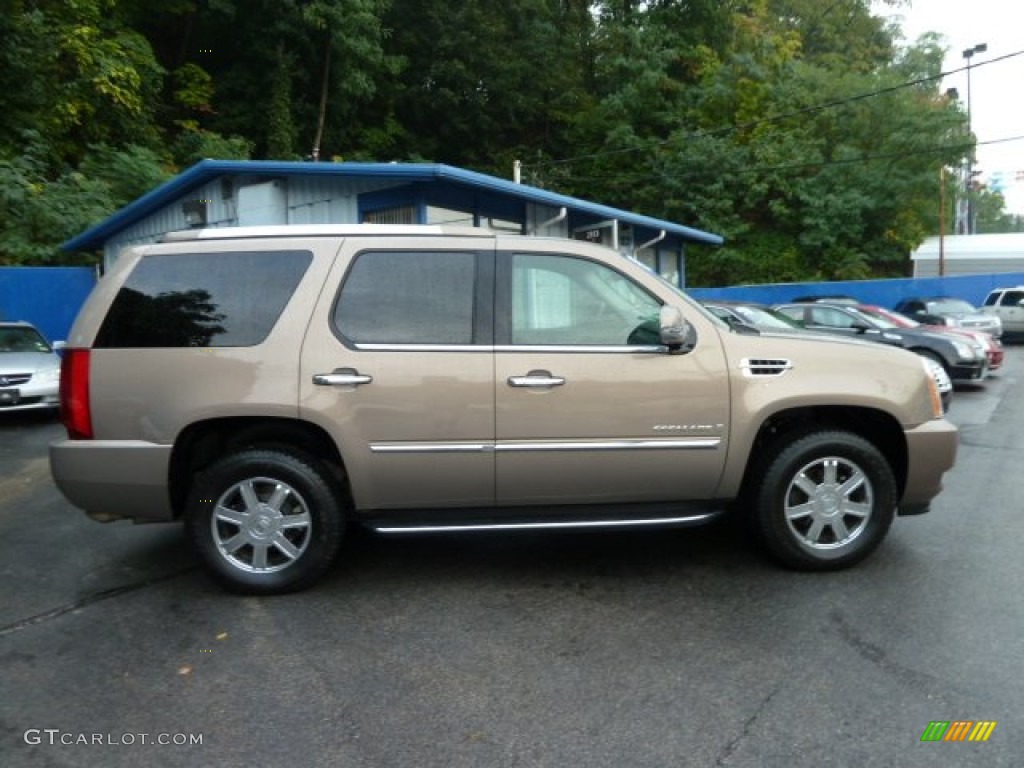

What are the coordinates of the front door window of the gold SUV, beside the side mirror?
(511, 254, 662, 345)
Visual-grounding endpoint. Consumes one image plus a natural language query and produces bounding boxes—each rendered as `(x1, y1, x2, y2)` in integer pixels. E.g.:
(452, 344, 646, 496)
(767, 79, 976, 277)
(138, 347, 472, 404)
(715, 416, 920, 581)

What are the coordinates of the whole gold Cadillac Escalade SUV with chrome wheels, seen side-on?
(50, 225, 956, 594)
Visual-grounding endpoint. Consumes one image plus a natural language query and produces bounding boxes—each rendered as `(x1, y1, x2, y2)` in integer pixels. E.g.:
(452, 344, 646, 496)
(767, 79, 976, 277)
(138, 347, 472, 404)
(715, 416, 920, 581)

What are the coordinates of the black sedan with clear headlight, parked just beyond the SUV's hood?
(775, 304, 988, 380)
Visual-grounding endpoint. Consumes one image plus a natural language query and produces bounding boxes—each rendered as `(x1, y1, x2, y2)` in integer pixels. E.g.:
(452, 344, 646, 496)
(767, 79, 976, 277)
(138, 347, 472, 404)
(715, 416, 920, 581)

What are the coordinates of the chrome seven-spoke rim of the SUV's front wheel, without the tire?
(784, 456, 874, 551)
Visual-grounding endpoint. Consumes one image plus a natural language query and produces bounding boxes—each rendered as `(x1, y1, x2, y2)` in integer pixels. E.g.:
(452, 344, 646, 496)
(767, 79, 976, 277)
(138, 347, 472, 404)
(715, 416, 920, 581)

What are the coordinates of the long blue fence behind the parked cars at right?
(686, 272, 1024, 307)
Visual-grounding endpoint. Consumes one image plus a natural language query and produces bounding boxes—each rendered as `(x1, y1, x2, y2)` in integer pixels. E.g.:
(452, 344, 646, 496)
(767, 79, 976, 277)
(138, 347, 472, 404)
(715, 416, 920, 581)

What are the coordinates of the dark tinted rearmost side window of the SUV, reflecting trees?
(95, 251, 312, 347)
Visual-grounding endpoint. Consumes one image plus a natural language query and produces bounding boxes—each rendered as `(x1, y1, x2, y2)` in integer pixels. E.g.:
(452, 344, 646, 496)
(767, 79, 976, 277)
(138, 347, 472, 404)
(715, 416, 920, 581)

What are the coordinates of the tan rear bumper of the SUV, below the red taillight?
(50, 439, 174, 522)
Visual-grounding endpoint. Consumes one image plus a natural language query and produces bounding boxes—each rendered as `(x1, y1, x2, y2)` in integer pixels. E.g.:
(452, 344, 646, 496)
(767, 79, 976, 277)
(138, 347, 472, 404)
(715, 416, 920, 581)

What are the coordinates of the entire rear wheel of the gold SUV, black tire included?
(185, 449, 345, 595)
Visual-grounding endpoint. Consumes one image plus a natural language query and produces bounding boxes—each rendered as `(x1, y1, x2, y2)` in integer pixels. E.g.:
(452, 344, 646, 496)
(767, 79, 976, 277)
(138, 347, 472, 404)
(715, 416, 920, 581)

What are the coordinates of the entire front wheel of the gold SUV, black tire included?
(754, 431, 898, 570)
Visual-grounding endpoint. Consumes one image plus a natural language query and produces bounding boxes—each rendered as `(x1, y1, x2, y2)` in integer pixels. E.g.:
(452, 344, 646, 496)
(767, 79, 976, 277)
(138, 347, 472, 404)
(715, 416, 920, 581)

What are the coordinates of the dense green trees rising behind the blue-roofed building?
(0, 0, 1013, 285)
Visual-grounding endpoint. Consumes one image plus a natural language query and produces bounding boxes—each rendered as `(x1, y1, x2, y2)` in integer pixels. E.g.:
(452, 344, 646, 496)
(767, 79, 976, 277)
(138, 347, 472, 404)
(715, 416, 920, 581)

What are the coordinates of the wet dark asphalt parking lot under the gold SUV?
(0, 356, 1024, 768)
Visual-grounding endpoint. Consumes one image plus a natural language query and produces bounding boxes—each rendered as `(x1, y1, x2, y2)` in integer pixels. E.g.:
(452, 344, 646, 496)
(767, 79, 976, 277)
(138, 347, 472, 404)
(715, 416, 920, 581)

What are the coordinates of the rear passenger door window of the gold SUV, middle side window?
(334, 251, 476, 344)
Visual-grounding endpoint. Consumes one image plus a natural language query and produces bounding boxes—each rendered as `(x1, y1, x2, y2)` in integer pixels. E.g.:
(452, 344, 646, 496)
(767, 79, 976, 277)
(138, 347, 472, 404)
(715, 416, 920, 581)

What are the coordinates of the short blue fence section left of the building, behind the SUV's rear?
(0, 266, 96, 341)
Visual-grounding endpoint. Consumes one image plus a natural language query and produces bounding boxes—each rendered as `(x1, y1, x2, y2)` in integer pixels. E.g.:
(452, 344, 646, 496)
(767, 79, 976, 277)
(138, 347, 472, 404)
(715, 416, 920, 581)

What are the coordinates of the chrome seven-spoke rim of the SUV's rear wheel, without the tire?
(210, 477, 312, 573)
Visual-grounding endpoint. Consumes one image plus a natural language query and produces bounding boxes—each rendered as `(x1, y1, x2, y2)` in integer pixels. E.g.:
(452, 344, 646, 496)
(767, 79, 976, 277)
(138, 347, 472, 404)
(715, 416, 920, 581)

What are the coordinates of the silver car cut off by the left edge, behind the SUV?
(0, 323, 60, 412)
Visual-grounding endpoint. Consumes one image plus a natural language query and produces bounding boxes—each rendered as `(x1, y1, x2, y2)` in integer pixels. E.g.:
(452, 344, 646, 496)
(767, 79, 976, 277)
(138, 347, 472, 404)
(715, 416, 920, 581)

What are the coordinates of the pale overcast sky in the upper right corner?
(876, 0, 1024, 214)
